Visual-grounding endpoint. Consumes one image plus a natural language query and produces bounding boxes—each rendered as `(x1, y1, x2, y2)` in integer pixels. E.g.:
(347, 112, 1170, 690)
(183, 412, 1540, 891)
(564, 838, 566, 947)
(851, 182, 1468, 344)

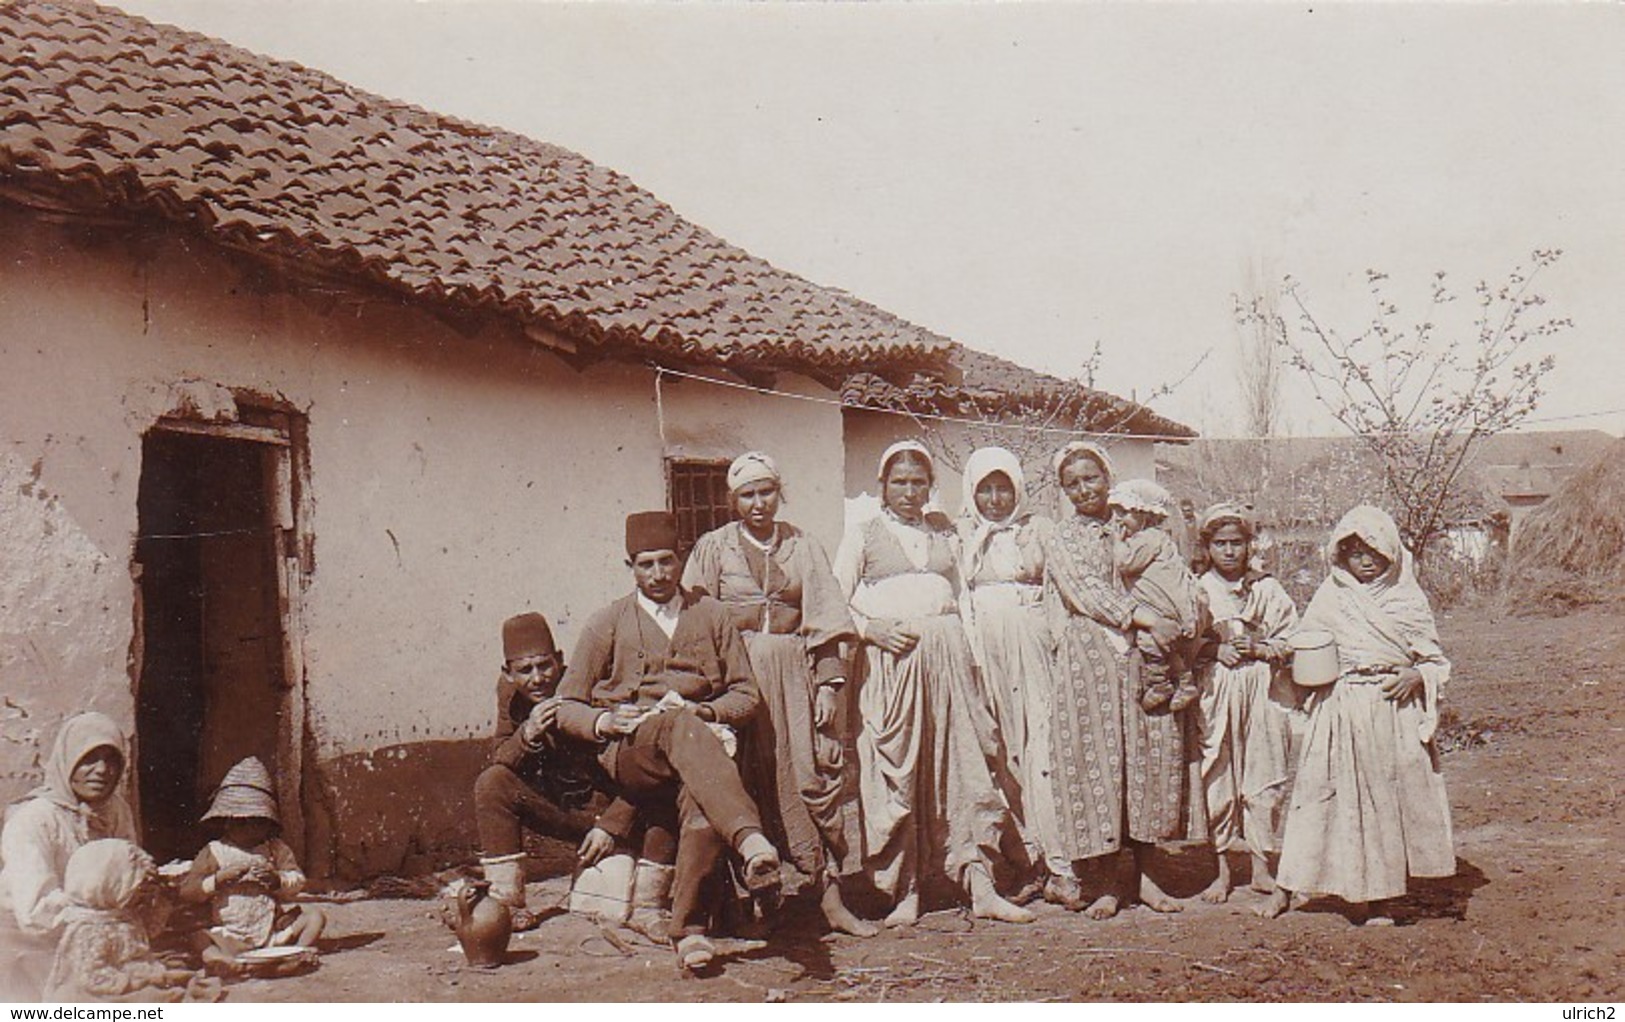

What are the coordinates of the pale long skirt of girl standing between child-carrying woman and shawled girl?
(1198, 661, 1290, 855)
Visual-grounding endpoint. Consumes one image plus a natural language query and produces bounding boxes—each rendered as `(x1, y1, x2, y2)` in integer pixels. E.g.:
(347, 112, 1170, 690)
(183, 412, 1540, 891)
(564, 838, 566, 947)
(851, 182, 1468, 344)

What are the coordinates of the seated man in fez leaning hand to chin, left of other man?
(475, 613, 637, 931)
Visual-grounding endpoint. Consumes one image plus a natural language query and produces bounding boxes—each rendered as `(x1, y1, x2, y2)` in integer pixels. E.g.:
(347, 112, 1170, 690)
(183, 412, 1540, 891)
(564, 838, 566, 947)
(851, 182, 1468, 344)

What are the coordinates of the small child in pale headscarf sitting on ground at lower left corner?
(44, 837, 197, 1001)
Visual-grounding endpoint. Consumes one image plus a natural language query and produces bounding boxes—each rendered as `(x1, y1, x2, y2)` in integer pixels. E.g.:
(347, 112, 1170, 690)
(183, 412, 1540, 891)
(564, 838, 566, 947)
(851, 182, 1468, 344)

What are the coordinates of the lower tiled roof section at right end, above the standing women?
(842, 344, 1198, 442)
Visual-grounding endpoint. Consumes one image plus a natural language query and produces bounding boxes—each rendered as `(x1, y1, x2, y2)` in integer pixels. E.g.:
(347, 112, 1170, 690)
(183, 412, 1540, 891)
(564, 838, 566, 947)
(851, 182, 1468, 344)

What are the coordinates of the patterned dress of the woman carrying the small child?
(1045, 515, 1190, 860)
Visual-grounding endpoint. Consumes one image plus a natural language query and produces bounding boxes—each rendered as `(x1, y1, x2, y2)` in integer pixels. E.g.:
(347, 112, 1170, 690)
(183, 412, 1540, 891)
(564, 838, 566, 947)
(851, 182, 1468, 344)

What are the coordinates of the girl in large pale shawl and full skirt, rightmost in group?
(1259, 505, 1456, 925)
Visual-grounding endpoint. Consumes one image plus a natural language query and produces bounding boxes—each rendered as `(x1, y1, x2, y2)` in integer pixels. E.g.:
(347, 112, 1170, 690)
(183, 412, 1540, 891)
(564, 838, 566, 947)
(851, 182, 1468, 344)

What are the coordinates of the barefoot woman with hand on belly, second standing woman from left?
(835, 440, 1034, 926)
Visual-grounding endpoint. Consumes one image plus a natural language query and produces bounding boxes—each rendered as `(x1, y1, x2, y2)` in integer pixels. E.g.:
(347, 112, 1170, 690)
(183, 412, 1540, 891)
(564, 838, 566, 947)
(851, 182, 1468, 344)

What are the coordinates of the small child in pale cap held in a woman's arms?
(1108, 479, 1201, 712)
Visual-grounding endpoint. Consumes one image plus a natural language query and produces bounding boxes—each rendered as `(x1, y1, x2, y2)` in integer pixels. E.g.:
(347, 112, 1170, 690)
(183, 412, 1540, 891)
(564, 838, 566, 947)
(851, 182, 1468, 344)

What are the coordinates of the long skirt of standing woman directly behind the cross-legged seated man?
(739, 632, 847, 877)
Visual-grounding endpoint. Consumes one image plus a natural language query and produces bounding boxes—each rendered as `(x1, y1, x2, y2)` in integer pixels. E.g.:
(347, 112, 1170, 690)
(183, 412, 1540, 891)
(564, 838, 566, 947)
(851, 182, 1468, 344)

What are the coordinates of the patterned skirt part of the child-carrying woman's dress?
(1050, 616, 1191, 860)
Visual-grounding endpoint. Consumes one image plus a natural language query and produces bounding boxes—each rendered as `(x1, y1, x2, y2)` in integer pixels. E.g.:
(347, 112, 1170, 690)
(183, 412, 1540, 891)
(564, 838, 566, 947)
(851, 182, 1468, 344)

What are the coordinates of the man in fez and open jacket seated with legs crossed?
(557, 512, 780, 970)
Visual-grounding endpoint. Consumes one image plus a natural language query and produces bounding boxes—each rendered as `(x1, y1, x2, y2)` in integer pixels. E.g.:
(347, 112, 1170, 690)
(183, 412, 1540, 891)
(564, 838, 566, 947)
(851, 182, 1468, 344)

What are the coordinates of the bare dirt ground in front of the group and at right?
(228, 606, 1625, 1003)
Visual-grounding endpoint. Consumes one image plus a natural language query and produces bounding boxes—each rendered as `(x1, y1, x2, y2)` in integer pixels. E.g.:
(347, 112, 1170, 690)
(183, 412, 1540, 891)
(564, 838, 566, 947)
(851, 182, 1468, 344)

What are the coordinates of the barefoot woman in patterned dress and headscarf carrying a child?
(1043, 440, 1186, 920)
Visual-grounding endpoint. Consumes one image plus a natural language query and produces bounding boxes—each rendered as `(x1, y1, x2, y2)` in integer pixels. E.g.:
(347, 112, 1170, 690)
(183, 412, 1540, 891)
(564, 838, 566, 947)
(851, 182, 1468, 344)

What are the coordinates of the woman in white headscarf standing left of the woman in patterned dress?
(959, 447, 1082, 910)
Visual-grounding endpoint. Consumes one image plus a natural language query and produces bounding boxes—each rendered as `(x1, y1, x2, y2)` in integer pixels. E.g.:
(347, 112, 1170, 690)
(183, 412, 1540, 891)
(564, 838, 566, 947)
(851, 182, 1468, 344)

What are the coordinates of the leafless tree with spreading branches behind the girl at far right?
(1237, 249, 1573, 564)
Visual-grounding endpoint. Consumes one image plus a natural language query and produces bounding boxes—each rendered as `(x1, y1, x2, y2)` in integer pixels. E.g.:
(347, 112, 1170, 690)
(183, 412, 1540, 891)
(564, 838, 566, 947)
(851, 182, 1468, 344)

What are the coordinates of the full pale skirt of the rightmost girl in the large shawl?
(1277, 676, 1456, 902)
